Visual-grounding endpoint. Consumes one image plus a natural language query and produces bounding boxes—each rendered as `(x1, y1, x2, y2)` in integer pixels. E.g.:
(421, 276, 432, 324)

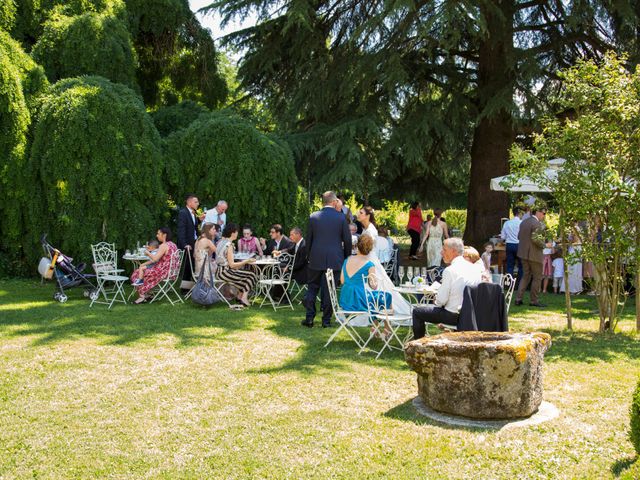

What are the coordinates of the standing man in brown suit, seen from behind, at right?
(516, 207, 547, 307)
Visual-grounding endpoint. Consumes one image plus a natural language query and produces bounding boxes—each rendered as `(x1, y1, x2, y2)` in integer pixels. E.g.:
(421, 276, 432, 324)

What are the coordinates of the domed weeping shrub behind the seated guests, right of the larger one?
(165, 113, 297, 232)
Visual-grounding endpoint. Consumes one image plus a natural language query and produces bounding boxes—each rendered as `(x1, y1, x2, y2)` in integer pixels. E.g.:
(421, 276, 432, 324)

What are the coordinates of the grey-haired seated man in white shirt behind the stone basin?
(413, 238, 480, 339)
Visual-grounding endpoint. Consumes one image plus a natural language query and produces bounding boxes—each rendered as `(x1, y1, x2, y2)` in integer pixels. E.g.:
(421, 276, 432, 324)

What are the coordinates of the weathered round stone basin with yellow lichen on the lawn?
(405, 332, 551, 419)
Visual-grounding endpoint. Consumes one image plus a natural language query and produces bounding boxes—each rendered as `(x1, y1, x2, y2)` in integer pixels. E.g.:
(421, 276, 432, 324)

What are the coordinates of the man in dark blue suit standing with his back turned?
(302, 192, 351, 328)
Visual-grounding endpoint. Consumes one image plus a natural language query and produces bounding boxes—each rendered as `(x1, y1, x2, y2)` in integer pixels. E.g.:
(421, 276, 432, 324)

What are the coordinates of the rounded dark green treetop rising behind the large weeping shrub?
(32, 12, 137, 88)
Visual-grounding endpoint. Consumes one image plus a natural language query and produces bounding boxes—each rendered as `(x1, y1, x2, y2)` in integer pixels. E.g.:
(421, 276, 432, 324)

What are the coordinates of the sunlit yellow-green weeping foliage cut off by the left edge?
(0, 31, 47, 272)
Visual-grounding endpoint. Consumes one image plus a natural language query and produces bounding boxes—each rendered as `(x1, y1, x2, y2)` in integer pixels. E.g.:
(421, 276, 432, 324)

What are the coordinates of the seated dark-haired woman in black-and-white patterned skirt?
(216, 223, 257, 307)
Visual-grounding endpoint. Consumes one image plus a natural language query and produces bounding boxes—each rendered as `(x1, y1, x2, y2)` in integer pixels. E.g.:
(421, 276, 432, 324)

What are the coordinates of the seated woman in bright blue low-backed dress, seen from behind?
(339, 235, 391, 335)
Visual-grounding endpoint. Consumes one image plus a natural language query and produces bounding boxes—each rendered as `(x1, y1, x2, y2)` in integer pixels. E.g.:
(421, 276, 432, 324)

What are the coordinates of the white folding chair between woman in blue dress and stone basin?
(360, 275, 413, 359)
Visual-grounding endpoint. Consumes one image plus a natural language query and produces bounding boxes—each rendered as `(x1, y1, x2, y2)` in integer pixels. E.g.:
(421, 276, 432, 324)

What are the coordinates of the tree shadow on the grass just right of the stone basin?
(542, 329, 640, 363)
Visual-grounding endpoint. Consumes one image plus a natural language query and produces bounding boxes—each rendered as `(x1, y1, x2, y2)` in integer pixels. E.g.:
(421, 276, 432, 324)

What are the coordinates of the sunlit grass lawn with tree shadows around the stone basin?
(0, 280, 640, 479)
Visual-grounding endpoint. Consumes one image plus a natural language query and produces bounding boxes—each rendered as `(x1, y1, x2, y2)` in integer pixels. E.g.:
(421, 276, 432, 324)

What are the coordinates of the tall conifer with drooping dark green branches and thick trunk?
(204, 0, 631, 243)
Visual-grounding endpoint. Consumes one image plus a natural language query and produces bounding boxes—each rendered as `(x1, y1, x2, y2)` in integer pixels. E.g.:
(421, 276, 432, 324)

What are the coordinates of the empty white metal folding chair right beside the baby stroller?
(89, 242, 129, 309)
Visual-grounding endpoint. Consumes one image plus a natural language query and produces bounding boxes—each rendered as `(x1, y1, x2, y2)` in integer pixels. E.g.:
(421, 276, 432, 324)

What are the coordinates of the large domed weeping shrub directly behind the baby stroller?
(25, 77, 166, 266)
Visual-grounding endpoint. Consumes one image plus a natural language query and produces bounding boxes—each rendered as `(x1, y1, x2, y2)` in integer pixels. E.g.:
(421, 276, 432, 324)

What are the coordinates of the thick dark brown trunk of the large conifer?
(464, 1, 515, 247)
